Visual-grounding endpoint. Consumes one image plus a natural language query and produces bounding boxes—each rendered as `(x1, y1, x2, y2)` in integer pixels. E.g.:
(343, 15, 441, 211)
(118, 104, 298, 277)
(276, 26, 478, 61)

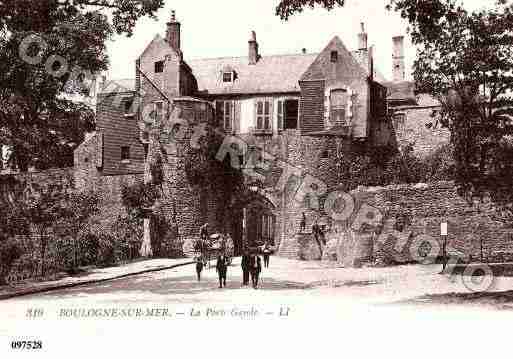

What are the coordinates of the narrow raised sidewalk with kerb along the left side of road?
(0, 258, 194, 300)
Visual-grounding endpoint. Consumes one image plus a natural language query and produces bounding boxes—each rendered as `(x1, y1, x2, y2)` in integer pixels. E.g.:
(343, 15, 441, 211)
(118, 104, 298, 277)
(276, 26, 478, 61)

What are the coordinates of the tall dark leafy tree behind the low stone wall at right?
(398, 0, 513, 220)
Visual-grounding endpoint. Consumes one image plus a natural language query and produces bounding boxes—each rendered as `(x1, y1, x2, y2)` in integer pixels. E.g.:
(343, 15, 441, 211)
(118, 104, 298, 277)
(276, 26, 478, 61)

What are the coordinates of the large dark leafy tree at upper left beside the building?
(0, 0, 164, 171)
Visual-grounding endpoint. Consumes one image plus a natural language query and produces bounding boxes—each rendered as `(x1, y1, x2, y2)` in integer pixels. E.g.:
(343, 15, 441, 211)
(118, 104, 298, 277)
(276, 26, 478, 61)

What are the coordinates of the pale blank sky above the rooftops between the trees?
(107, 0, 491, 79)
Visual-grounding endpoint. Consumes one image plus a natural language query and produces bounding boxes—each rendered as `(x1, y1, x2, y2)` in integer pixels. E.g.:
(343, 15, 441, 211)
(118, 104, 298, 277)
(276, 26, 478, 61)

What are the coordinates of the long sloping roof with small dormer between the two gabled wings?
(187, 54, 317, 95)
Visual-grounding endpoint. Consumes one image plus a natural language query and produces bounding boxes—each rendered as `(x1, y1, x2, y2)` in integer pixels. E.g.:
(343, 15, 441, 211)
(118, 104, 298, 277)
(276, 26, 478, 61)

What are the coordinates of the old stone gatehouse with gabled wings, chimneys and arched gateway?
(75, 13, 446, 258)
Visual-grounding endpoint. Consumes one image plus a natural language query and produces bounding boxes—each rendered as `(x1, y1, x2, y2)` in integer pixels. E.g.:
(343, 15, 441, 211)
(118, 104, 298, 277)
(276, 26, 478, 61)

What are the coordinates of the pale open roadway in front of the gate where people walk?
(5, 257, 513, 307)
